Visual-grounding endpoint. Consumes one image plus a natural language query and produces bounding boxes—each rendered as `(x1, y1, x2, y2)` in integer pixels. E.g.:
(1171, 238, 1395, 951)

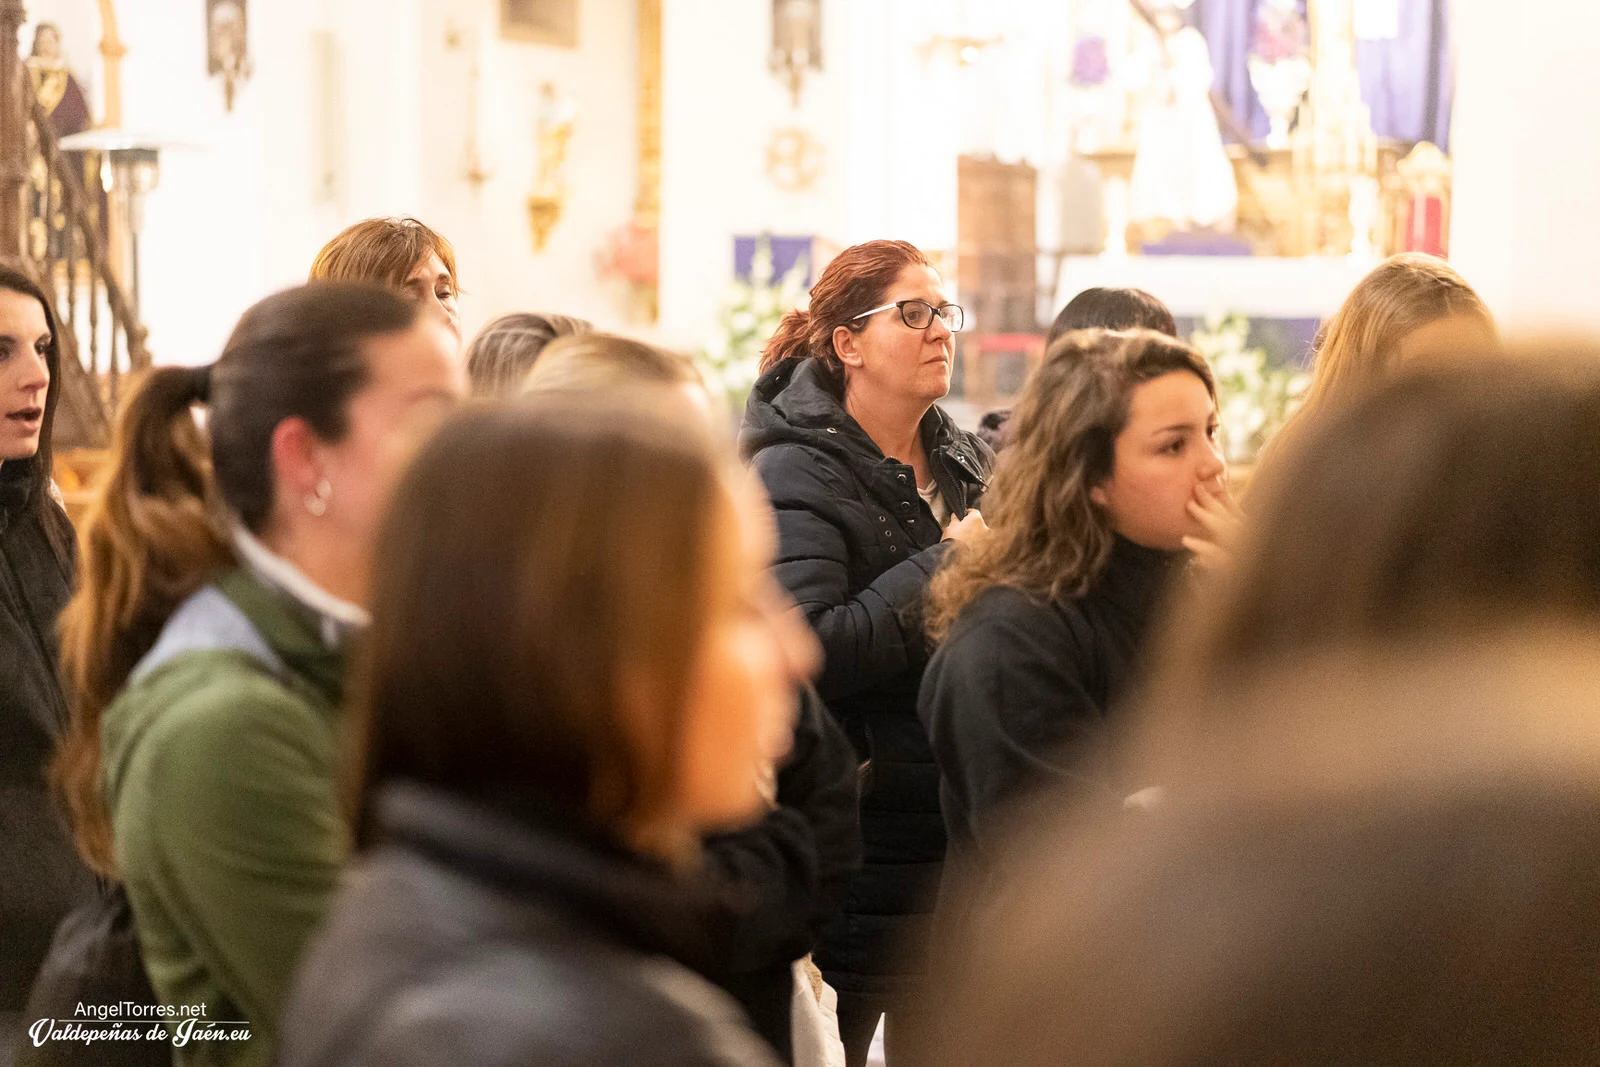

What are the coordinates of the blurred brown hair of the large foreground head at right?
(1155, 344, 1600, 716)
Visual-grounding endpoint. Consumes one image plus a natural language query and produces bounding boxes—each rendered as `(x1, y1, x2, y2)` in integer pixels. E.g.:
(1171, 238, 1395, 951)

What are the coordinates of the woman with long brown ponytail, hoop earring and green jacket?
(58, 283, 466, 1065)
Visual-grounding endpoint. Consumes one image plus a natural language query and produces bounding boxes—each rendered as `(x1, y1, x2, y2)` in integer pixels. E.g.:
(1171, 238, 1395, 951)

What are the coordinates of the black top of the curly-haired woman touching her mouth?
(918, 537, 1187, 907)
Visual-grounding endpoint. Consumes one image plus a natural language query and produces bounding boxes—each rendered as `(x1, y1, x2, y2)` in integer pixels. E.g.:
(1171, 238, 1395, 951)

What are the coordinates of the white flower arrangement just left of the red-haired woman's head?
(698, 235, 811, 414)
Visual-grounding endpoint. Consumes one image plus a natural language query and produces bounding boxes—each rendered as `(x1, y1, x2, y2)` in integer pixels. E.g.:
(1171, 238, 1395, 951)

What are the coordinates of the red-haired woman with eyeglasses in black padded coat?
(739, 240, 994, 1067)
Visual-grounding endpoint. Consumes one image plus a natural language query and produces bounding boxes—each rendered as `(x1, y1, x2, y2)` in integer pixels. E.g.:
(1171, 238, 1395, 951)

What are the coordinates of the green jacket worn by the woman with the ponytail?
(101, 569, 349, 1067)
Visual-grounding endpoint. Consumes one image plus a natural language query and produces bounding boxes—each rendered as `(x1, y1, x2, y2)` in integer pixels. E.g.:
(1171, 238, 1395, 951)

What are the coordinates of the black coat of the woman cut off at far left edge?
(0, 461, 94, 1011)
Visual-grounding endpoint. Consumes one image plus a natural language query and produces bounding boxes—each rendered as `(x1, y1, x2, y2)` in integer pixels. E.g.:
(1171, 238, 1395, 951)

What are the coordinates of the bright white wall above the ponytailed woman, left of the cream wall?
(117, 0, 421, 363)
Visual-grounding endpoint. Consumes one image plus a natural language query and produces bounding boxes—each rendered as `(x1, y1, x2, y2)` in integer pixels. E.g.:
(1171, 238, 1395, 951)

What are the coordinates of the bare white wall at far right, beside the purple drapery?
(1450, 0, 1600, 333)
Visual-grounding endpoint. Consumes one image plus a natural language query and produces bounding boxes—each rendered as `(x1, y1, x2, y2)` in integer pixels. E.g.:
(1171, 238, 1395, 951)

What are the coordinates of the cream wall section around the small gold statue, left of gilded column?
(421, 0, 640, 333)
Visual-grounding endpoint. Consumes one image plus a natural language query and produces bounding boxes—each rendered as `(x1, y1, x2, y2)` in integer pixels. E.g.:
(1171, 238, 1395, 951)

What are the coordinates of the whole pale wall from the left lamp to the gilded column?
(75, 0, 637, 363)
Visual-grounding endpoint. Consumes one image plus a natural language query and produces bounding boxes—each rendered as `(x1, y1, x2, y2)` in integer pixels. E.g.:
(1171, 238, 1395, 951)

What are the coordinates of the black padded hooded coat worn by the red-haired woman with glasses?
(739, 360, 994, 993)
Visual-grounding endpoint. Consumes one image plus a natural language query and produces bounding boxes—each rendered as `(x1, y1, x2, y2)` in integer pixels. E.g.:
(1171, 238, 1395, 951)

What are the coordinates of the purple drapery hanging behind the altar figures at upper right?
(1189, 0, 1454, 152)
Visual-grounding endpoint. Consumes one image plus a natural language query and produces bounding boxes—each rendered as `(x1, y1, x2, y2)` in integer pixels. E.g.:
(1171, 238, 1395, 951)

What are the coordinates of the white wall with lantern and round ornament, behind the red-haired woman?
(661, 0, 1070, 346)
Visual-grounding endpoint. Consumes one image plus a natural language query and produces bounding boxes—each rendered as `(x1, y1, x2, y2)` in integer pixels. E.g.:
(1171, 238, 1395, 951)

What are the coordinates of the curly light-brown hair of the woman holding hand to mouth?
(925, 330, 1216, 640)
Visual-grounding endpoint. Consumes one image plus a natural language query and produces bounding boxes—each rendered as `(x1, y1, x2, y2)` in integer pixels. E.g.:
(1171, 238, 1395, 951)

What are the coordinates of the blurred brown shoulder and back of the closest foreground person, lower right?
(936, 625, 1600, 1067)
